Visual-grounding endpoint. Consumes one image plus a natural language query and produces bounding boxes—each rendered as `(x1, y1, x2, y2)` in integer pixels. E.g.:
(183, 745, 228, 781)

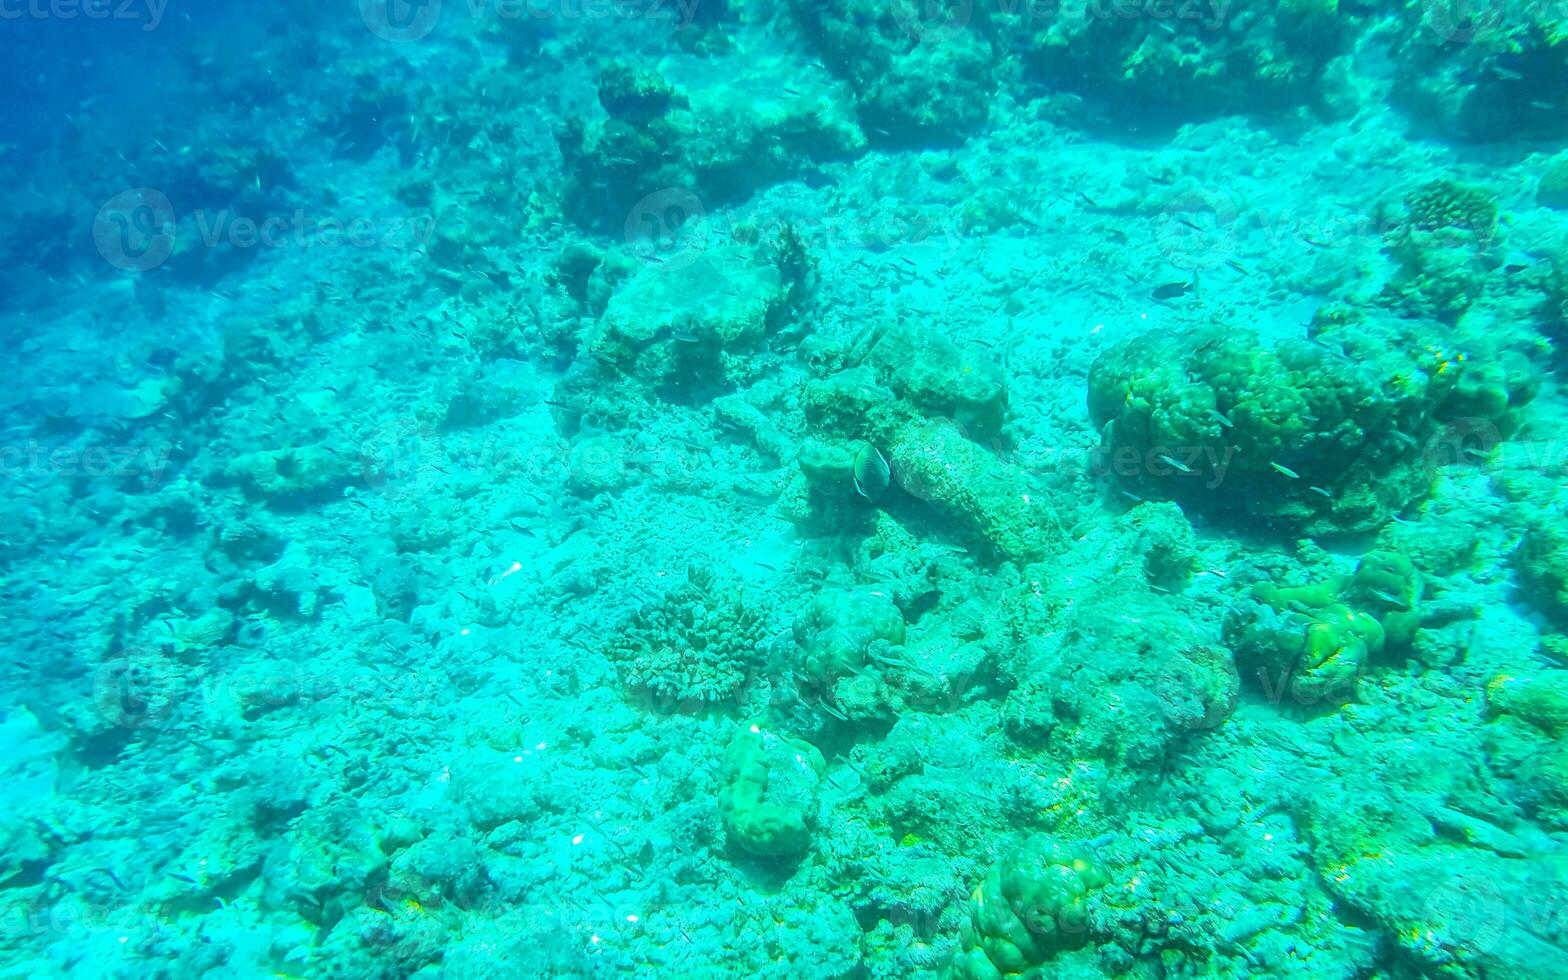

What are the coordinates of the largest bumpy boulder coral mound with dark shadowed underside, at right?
(1088, 307, 1537, 535)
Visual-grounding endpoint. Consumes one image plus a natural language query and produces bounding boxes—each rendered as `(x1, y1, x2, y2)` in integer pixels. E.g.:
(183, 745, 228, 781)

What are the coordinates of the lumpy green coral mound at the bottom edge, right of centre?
(949, 837, 1107, 980)
